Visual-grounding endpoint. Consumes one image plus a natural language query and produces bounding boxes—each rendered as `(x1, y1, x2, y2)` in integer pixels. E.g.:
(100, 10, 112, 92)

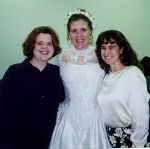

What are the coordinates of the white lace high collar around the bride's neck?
(71, 46, 93, 62)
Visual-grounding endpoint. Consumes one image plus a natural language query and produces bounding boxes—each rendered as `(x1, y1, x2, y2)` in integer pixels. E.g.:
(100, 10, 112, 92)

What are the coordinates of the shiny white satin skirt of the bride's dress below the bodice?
(49, 105, 110, 149)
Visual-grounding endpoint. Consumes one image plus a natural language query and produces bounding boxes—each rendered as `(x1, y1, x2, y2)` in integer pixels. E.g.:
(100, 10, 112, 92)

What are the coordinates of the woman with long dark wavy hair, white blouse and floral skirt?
(96, 30, 150, 148)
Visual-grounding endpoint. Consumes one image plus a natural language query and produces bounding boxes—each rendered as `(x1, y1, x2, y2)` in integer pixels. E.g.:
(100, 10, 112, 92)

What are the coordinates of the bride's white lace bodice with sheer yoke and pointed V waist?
(54, 46, 104, 144)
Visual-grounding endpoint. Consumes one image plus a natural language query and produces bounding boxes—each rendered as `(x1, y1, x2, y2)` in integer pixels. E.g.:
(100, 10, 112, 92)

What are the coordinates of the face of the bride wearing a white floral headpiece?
(69, 19, 91, 50)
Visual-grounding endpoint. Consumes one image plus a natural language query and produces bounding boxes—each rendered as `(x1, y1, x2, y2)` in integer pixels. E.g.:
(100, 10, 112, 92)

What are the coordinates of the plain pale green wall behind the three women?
(0, 0, 150, 78)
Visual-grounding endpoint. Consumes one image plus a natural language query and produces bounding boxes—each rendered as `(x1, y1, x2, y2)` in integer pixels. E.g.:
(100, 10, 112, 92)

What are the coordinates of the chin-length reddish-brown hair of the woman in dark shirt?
(22, 26, 61, 60)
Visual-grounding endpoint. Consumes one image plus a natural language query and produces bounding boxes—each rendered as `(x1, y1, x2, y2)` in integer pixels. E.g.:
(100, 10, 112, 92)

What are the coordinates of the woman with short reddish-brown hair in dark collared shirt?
(0, 26, 64, 149)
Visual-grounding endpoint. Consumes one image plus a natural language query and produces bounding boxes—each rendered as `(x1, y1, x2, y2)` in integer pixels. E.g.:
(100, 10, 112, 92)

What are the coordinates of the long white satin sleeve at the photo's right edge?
(128, 66, 150, 147)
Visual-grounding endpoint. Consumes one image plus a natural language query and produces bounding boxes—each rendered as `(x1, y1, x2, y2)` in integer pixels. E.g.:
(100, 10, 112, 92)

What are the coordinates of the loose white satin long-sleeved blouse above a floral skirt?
(97, 66, 150, 147)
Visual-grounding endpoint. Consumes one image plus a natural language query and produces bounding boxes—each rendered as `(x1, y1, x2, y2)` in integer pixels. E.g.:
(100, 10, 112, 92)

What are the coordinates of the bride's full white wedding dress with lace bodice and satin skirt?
(49, 46, 110, 149)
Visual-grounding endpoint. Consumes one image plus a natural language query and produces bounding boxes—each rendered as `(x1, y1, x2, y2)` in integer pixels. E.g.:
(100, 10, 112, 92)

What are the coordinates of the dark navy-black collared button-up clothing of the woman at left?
(0, 60, 64, 149)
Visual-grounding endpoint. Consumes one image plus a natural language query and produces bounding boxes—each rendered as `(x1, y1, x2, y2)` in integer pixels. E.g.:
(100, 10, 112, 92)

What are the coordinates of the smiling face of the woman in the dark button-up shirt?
(33, 33, 54, 62)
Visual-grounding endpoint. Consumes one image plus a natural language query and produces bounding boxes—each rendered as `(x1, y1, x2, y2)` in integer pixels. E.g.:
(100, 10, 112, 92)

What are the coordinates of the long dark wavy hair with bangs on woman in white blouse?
(96, 30, 141, 73)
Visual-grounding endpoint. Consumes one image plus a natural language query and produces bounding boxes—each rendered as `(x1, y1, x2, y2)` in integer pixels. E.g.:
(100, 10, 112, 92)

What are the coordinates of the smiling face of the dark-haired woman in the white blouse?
(101, 42, 123, 67)
